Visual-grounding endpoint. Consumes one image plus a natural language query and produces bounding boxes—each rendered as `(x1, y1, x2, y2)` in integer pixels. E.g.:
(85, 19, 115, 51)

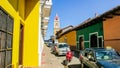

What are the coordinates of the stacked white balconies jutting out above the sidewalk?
(41, 0, 52, 37)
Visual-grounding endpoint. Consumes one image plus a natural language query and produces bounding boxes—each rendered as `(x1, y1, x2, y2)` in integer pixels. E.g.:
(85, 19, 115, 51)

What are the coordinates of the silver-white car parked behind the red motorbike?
(56, 43, 70, 55)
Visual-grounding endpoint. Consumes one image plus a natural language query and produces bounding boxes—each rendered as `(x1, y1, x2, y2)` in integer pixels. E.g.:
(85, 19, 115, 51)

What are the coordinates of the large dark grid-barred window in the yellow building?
(0, 8, 13, 68)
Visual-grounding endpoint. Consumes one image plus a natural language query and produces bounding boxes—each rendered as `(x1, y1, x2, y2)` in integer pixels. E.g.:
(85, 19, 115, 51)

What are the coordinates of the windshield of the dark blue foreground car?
(96, 50, 120, 60)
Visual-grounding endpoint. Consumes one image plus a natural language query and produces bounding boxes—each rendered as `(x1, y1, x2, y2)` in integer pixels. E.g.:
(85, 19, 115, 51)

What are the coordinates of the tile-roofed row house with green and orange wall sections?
(75, 6, 120, 51)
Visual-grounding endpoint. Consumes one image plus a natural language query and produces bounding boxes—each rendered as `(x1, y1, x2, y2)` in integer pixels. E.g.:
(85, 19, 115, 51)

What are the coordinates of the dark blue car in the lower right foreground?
(79, 48, 120, 68)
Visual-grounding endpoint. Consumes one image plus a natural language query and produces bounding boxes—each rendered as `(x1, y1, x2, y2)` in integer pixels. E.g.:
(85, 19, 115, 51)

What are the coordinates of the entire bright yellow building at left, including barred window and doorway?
(0, 0, 52, 68)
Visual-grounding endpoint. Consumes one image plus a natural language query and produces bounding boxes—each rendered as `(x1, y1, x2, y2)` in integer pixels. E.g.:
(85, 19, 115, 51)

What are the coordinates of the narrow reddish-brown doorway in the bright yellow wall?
(19, 24, 24, 65)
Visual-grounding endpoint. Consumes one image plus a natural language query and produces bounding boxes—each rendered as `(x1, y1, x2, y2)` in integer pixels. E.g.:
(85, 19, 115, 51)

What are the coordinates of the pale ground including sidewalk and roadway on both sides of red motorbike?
(41, 45, 80, 68)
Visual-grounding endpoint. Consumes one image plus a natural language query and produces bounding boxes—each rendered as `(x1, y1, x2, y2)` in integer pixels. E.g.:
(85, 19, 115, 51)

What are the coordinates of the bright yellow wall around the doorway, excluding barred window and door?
(0, 0, 40, 68)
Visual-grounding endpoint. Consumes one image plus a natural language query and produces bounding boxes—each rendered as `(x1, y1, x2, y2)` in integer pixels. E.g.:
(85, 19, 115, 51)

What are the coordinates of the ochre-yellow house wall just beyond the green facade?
(58, 31, 76, 46)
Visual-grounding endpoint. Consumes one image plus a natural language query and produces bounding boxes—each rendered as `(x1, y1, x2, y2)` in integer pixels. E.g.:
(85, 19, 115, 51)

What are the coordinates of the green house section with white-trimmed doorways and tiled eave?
(76, 19, 103, 50)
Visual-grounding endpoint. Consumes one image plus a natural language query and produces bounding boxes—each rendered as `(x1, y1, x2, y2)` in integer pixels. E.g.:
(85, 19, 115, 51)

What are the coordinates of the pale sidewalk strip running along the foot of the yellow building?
(41, 45, 64, 68)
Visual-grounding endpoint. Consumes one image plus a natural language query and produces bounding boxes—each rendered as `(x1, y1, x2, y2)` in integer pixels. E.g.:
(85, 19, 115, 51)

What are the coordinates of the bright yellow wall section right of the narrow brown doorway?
(23, 0, 40, 67)
